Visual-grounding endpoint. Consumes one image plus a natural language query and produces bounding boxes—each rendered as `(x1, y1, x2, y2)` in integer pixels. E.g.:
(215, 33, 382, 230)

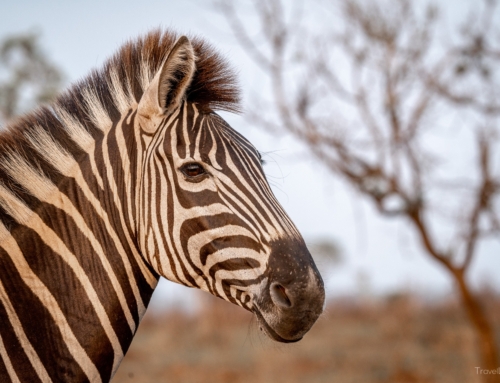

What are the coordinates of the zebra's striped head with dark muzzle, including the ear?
(135, 37, 325, 342)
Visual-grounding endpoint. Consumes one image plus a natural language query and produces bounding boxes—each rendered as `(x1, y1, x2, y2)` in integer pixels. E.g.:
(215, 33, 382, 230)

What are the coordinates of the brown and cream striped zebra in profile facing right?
(0, 29, 325, 382)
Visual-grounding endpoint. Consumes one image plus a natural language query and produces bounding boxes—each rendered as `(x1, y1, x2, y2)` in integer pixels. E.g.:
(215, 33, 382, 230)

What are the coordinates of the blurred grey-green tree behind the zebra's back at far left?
(0, 32, 63, 124)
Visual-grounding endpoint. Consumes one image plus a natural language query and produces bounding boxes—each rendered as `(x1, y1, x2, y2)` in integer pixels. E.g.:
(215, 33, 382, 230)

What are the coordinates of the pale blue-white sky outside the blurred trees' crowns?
(0, 0, 500, 312)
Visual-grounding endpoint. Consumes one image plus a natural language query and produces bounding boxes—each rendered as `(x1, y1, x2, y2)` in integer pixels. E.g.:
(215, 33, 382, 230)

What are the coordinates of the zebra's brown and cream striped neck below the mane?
(0, 98, 158, 381)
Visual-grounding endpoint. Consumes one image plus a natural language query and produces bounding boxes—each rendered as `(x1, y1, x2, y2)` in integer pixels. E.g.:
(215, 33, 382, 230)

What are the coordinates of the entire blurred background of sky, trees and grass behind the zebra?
(0, 0, 500, 382)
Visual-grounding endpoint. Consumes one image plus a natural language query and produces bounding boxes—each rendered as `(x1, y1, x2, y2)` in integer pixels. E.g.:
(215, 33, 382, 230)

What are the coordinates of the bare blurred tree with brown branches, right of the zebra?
(216, 0, 500, 382)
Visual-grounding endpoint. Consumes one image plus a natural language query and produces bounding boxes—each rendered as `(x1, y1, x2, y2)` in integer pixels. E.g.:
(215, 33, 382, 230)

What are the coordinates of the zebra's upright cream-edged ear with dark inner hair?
(137, 36, 196, 133)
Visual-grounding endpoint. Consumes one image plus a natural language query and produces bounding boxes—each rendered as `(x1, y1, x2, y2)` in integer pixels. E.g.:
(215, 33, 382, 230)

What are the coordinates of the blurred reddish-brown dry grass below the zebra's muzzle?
(113, 294, 500, 383)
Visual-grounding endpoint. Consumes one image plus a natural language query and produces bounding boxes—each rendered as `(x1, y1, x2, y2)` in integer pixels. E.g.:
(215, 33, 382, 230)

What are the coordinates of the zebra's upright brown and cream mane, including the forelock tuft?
(0, 29, 240, 231)
